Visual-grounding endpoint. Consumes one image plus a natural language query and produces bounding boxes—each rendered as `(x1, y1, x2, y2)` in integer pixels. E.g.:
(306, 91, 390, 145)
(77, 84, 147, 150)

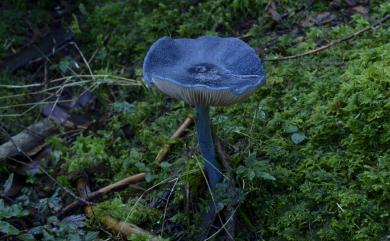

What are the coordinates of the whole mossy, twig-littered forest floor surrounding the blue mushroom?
(0, 0, 390, 241)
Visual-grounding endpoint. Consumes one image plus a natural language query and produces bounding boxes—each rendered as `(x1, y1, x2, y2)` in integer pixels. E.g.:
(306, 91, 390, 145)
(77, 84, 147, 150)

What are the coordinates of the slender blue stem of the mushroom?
(196, 106, 222, 190)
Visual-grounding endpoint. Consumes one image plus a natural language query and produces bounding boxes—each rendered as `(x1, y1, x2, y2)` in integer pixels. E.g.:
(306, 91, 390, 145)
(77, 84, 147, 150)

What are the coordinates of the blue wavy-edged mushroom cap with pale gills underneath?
(143, 36, 265, 106)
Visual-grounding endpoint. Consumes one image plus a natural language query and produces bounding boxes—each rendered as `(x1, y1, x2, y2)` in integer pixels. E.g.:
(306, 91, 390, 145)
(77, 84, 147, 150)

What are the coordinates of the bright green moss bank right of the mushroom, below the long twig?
(238, 19, 390, 240)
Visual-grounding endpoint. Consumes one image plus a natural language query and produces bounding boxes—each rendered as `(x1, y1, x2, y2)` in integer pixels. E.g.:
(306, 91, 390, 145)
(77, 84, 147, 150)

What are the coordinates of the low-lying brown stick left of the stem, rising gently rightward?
(60, 173, 145, 217)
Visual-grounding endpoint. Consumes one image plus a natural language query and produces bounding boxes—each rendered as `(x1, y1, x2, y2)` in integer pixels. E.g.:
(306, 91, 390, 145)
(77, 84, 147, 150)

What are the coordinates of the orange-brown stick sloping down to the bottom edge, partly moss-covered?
(77, 178, 157, 240)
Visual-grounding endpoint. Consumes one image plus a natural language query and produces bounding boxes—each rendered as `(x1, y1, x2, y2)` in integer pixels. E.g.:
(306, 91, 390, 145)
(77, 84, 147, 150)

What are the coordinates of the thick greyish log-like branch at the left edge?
(0, 119, 56, 162)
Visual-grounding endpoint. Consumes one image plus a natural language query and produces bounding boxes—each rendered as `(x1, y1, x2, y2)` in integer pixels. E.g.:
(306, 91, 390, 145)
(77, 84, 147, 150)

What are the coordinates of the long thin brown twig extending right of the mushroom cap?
(263, 14, 390, 61)
